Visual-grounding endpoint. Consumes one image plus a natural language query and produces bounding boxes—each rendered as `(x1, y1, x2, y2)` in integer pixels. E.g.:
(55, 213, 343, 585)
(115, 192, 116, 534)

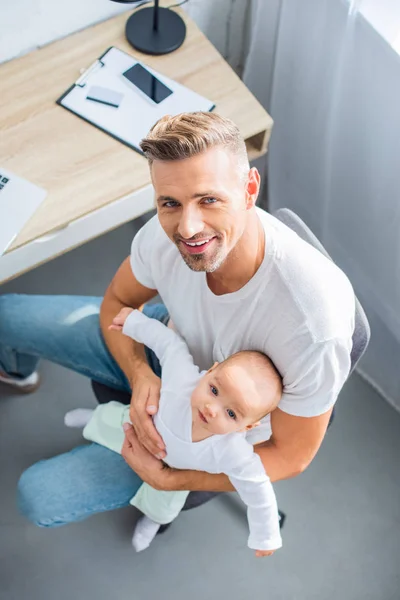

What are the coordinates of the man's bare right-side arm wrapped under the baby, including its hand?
(122, 408, 332, 492)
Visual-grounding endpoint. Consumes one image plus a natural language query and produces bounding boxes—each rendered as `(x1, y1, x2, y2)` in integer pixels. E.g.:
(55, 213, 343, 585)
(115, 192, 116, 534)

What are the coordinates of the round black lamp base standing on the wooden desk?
(125, 8, 186, 55)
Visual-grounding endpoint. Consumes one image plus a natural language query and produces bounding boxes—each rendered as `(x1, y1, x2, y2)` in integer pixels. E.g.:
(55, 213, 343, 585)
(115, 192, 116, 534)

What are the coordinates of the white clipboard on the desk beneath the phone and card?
(56, 46, 215, 155)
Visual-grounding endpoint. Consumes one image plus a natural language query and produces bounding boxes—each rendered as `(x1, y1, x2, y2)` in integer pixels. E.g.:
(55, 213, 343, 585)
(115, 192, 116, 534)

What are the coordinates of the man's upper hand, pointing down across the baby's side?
(129, 368, 165, 459)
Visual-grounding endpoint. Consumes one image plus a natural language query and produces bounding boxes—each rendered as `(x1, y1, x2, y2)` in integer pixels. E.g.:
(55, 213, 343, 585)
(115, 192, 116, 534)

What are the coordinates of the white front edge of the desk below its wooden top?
(0, 185, 154, 283)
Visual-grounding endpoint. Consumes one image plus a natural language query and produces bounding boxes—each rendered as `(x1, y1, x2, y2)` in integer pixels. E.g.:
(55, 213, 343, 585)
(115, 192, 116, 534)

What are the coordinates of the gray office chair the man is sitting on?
(92, 208, 371, 516)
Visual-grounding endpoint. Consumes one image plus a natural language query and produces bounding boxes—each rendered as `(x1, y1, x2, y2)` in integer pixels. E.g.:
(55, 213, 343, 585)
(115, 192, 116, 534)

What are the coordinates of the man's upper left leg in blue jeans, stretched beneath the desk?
(0, 294, 129, 391)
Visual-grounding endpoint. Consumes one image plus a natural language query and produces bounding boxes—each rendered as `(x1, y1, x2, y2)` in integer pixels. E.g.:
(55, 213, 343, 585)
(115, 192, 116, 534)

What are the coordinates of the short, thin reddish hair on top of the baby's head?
(224, 350, 283, 418)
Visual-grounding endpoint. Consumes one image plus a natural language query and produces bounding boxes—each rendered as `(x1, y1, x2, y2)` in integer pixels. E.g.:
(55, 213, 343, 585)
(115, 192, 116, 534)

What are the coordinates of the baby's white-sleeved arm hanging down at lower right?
(220, 438, 282, 551)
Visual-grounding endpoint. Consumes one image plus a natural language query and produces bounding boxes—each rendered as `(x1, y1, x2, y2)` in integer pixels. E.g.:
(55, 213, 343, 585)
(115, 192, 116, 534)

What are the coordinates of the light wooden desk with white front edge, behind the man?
(0, 0, 272, 283)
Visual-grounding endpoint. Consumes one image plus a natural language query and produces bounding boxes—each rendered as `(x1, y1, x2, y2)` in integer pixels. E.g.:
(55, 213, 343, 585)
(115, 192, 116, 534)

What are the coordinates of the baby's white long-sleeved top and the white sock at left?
(84, 310, 282, 550)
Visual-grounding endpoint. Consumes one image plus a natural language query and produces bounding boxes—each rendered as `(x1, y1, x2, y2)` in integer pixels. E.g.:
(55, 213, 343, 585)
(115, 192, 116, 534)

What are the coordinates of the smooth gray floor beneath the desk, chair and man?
(0, 219, 400, 600)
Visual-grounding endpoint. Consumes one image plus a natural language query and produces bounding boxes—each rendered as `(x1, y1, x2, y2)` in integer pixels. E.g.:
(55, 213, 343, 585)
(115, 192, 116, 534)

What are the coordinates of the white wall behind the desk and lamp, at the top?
(0, 0, 248, 69)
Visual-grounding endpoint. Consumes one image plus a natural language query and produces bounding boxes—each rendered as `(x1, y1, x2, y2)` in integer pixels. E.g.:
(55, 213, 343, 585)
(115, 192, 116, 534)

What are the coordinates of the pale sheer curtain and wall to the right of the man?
(245, 0, 400, 411)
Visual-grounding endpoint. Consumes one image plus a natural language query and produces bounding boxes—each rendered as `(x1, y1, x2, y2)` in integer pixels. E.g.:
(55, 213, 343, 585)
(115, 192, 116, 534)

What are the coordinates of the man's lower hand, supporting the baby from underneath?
(121, 423, 171, 490)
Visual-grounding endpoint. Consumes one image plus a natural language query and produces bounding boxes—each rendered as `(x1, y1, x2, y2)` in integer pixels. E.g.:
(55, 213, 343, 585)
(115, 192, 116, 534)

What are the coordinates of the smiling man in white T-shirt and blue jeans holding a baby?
(0, 113, 354, 526)
